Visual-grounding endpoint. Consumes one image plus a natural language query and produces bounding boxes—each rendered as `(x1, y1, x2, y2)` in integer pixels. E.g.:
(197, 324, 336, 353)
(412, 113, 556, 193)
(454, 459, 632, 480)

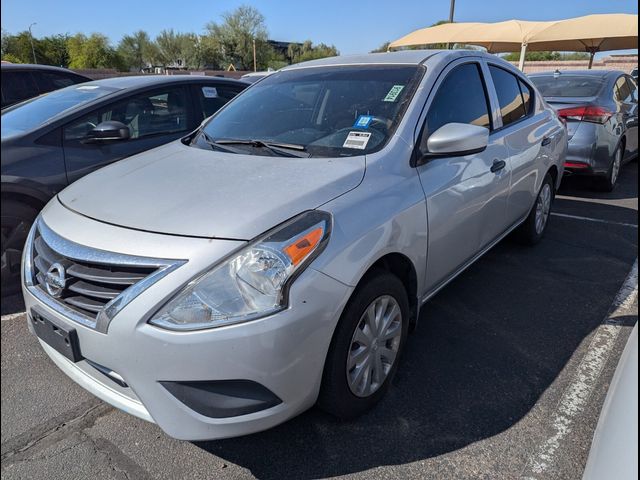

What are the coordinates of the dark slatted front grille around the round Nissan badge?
(32, 231, 158, 321)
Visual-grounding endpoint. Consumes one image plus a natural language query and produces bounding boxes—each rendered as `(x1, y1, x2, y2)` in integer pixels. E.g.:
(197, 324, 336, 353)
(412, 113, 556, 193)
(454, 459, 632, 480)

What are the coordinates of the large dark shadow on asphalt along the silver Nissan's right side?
(196, 193, 637, 479)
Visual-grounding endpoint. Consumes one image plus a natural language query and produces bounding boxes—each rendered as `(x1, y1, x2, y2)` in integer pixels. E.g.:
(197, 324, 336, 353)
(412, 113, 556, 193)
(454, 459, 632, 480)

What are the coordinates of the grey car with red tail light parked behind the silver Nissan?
(529, 70, 638, 191)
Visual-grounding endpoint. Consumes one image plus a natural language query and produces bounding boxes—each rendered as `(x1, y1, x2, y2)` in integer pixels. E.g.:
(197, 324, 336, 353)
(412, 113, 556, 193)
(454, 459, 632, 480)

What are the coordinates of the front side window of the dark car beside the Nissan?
(64, 87, 189, 140)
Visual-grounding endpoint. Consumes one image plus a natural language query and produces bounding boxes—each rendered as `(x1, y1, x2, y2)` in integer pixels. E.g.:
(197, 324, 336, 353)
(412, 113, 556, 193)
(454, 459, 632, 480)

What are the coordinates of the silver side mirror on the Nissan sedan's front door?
(424, 123, 489, 157)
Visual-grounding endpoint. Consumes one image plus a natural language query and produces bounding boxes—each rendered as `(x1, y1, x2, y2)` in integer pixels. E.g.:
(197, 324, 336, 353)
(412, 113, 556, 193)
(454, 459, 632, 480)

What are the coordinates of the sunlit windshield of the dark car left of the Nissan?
(2, 85, 118, 139)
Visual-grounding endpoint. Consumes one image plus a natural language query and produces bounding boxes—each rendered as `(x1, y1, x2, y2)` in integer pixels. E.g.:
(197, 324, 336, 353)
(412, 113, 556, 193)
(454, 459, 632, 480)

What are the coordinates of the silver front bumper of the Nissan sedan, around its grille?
(23, 202, 352, 440)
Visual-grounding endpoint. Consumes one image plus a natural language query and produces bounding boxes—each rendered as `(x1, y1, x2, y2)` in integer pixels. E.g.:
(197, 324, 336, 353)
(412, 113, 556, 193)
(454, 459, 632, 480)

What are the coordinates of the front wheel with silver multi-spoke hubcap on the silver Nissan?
(318, 270, 409, 419)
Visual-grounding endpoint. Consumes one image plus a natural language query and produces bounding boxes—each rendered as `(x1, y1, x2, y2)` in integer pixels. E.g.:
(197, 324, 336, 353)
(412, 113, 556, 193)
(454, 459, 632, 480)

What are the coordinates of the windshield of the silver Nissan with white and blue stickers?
(197, 65, 424, 157)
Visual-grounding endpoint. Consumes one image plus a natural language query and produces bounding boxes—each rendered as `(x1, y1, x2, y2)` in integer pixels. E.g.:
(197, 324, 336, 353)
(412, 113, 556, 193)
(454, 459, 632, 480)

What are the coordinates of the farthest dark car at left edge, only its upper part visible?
(2, 63, 91, 108)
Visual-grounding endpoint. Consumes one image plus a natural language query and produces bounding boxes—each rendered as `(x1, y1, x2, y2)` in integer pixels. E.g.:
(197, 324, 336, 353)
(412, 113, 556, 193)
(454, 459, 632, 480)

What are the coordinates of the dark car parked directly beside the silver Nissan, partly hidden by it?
(2, 73, 249, 296)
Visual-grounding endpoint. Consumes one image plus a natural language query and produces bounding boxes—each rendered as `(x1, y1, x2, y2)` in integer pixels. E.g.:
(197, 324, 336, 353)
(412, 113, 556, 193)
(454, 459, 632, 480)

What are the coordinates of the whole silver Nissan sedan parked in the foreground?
(22, 51, 567, 440)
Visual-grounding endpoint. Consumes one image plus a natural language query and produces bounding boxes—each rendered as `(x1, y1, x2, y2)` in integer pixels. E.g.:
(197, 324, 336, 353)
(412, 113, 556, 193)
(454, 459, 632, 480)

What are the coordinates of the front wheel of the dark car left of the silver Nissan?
(1, 200, 38, 297)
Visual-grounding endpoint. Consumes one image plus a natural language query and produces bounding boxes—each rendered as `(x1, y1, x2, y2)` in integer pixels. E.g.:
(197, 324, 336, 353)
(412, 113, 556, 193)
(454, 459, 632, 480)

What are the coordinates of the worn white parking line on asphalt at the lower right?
(521, 258, 638, 480)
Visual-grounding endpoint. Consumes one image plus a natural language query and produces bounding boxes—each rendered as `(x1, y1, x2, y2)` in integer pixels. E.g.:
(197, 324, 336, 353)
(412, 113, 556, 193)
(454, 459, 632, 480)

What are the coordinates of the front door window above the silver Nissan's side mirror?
(420, 63, 492, 151)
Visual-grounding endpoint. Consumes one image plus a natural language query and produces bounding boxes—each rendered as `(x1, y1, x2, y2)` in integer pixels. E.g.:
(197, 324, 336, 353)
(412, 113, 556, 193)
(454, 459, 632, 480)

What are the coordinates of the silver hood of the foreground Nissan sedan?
(58, 141, 365, 240)
